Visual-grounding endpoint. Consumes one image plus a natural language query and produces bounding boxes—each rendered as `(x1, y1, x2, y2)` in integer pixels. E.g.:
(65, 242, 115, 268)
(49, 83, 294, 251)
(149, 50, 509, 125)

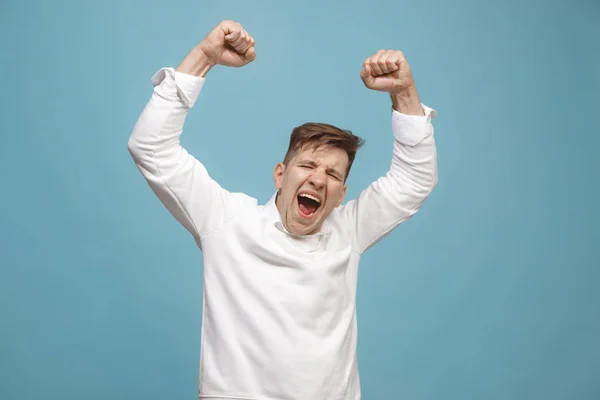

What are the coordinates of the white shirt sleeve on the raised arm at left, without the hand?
(128, 68, 237, 239)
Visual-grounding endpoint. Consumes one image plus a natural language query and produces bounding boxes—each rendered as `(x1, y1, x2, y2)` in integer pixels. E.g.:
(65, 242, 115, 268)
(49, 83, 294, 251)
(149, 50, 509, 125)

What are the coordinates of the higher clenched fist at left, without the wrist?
(200, 21, 256, 67)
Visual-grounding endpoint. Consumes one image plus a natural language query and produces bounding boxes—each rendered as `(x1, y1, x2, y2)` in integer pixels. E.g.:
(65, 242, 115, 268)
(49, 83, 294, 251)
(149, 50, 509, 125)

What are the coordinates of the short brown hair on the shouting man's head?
(283, 122, 365, 180)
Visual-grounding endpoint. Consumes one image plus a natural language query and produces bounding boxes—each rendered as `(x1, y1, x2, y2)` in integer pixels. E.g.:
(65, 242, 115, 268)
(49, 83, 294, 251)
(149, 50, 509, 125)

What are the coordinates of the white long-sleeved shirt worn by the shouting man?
(128, 68, 437, 400)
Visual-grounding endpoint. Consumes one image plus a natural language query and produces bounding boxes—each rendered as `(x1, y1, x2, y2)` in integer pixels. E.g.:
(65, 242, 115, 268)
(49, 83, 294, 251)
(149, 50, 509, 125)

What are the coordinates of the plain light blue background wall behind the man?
(0, 0, 600, 400)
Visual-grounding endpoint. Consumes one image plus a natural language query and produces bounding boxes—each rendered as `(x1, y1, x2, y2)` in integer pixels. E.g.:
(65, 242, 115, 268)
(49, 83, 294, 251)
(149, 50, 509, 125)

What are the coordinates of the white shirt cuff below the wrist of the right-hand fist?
(392, 104, 437, 146)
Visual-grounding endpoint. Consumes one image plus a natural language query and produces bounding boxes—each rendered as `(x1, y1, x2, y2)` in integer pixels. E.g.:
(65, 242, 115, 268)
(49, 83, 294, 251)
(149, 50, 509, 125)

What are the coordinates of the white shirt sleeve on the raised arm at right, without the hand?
(342, 104, 438, 253)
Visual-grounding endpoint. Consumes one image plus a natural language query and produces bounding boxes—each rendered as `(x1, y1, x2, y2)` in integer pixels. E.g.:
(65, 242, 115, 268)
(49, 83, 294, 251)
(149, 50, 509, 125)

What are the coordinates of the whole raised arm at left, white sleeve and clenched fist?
(128, 21, 256, 239)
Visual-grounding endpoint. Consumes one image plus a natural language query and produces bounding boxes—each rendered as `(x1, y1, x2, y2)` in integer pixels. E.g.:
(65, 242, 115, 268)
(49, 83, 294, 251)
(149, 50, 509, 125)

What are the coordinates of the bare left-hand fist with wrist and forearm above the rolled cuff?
(177, 21, 256, 77)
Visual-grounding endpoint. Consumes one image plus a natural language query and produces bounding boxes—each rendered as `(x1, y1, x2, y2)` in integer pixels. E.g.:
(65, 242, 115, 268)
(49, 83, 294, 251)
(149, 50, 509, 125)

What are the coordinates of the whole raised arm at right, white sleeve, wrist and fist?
(343, 50, 438, 253)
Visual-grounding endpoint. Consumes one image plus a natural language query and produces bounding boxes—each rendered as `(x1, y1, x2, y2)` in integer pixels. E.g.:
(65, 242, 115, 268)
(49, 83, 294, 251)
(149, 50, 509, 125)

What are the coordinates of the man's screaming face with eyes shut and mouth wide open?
(274, 146, 348, 235)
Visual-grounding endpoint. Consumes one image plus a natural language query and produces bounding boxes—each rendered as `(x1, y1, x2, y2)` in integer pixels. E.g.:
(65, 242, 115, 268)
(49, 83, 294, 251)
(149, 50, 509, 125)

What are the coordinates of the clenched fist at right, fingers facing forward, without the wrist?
(360, 50, 414, 94)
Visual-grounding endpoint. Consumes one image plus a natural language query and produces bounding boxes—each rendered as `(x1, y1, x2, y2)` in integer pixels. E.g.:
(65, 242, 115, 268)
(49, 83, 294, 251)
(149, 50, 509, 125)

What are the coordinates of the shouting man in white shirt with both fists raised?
(128, 21, 437, 400)
